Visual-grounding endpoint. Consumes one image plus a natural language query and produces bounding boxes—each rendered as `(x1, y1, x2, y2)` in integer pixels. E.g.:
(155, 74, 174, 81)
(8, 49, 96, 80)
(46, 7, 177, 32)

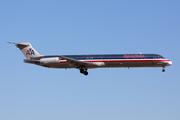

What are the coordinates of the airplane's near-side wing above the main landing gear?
(57, 55, 99, 68)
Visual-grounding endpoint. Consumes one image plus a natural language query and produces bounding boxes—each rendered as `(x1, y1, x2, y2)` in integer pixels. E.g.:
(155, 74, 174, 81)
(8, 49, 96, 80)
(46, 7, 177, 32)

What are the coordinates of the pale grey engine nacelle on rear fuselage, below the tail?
(40, 57, 59, 64)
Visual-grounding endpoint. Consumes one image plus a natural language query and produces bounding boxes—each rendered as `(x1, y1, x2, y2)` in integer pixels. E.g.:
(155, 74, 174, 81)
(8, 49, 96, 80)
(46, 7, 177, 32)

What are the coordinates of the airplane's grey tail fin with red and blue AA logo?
(8, 42, 43, 59)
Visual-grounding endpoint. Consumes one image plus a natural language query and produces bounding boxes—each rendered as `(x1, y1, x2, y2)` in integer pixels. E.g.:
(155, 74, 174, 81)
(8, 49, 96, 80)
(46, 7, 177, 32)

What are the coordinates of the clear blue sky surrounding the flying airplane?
(0, 0, 180, 120)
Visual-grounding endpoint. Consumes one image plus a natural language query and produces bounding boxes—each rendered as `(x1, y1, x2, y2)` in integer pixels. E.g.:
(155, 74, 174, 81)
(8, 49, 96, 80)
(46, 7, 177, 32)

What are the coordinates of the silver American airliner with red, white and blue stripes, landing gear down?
(8, 42, 172, 75)
